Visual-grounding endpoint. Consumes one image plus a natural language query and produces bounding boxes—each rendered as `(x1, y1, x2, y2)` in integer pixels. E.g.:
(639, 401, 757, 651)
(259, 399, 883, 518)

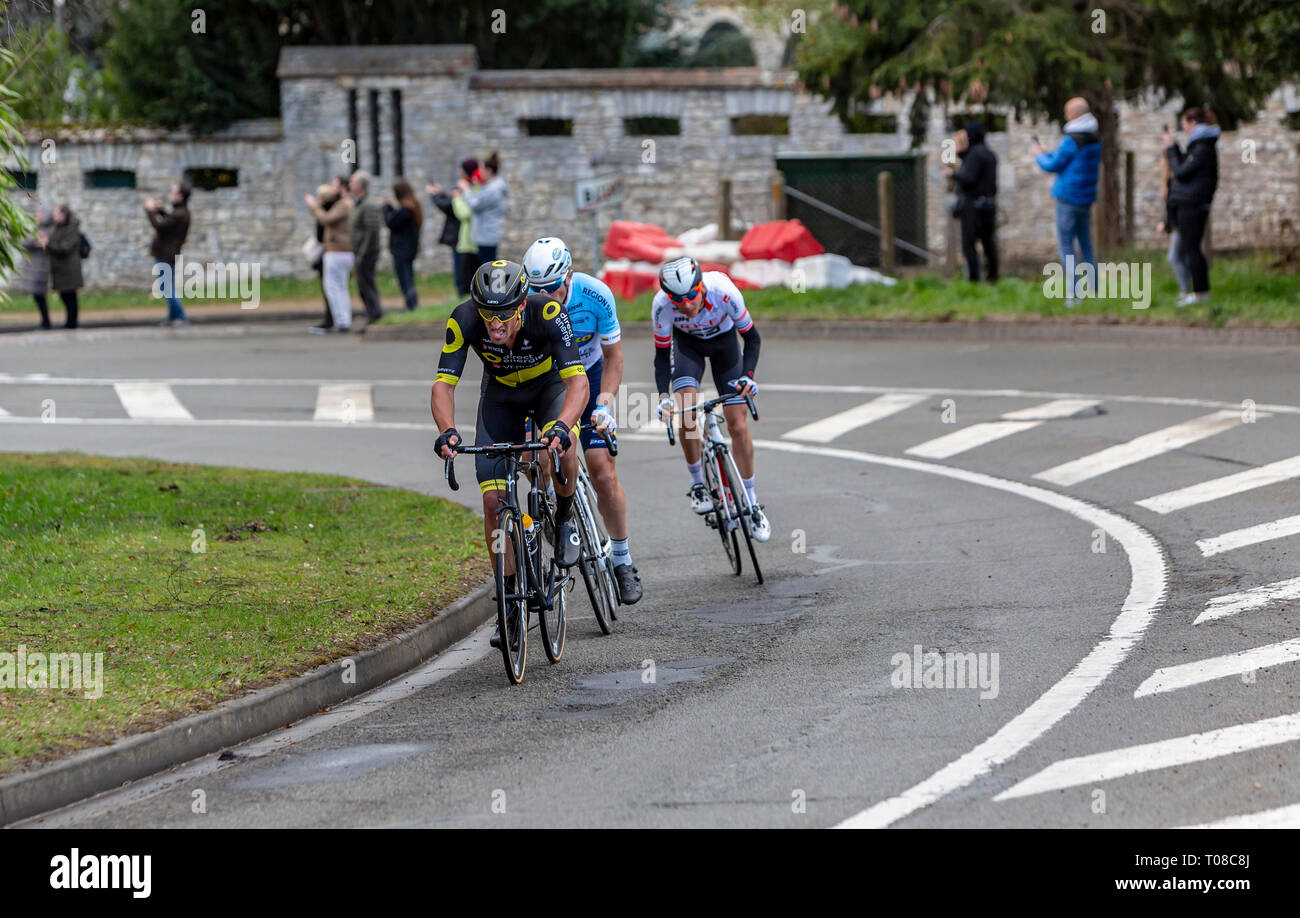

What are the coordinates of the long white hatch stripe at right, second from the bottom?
(993, 714, 1300, 801)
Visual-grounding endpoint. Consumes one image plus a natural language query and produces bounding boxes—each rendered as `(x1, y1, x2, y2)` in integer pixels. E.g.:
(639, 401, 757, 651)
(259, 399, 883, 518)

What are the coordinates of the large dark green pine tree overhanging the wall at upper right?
(796, 0, 1300, 242)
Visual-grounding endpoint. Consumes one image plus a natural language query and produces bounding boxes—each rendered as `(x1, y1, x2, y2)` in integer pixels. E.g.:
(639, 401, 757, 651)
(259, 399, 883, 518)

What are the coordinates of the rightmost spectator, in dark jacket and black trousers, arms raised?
(1164, 105, 1219, 306)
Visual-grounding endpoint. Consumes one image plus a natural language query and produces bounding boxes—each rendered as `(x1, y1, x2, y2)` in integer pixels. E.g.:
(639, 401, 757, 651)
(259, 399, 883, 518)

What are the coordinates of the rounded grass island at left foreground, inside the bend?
(0, 452, 488, 774)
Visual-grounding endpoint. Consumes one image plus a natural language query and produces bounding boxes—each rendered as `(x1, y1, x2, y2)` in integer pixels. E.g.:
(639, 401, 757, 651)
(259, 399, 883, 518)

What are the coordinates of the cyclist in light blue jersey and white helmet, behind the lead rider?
(524, 237, 641, 605)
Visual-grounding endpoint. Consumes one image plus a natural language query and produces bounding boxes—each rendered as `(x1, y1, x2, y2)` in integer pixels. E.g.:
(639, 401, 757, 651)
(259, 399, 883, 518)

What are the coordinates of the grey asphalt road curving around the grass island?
(0, 328, 1300, 827)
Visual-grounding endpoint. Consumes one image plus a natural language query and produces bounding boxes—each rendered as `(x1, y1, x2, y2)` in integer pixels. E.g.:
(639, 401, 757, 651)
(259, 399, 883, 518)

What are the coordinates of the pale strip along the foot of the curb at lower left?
(12, 625, 495, 828)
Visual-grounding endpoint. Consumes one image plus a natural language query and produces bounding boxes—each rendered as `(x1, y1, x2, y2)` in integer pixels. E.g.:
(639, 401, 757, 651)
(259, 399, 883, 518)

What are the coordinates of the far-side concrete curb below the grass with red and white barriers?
(364, 319, 1300, 347)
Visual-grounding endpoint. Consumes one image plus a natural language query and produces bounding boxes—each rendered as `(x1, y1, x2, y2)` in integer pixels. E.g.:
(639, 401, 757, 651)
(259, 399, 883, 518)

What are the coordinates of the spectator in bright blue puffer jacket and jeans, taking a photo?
(1031, 98, 1101, 307)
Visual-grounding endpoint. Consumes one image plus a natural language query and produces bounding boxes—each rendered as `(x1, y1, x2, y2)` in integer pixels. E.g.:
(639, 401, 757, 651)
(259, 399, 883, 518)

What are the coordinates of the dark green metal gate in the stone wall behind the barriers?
(776, 153, 926, 268)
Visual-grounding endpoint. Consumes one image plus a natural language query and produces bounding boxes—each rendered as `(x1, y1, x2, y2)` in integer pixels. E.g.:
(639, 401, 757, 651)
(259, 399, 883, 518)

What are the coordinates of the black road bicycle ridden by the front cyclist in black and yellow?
(443, 441, 573, 685)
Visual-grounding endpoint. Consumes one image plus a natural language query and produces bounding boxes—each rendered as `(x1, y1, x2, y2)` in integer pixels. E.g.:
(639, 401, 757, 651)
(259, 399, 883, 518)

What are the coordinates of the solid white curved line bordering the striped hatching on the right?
(754, 439, 1169, 828)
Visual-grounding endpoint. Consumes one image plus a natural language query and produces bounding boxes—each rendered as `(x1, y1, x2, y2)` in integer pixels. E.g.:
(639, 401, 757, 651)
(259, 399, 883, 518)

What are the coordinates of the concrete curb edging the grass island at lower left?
(0, 583, 497, 826)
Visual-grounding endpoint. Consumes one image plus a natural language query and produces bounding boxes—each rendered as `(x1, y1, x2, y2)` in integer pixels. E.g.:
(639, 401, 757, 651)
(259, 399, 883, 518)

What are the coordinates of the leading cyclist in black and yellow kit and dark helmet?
(429, 261, 589, 644)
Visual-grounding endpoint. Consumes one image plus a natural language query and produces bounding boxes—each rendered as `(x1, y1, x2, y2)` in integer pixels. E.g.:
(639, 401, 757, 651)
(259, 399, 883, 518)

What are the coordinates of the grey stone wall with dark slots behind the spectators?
(5, 46, 1300, 286)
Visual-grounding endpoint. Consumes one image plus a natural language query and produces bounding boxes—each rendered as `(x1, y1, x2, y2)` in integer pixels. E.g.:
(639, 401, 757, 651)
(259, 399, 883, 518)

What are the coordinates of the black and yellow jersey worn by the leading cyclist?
(437, 294, 586, 386)
